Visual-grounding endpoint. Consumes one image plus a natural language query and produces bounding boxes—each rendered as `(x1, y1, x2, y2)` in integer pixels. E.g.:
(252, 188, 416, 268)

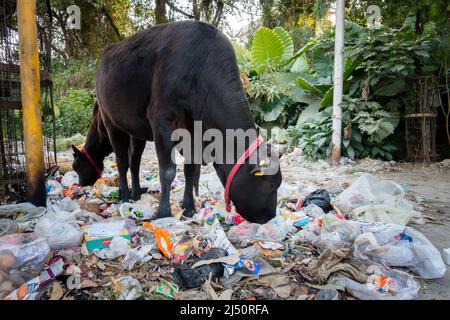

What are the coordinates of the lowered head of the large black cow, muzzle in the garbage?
(230, 145, 282, 224)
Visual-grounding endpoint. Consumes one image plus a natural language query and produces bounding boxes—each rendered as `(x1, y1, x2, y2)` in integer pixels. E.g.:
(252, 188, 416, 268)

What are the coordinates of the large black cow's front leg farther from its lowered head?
(151, 120, 176, 219)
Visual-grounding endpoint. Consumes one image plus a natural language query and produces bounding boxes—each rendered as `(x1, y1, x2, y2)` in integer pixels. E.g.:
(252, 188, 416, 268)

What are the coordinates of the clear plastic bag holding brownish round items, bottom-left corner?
(0, 233, 50, 299)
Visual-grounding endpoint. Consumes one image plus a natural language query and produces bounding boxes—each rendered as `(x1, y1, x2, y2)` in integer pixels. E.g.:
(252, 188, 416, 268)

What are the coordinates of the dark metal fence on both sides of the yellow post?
(0, 0, 57, 203)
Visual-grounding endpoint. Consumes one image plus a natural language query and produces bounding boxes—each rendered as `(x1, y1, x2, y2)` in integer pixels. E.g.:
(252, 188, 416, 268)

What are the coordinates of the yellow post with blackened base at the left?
(17, 0, 46, 206)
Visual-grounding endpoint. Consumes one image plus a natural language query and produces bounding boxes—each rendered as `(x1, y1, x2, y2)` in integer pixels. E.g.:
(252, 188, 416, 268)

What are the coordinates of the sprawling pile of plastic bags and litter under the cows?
(0, 160, 446, 300)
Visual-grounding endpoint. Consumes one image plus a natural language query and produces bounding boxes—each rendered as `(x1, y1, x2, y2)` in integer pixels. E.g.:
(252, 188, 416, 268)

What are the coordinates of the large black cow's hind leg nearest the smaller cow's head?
(108, 130, 130, 202)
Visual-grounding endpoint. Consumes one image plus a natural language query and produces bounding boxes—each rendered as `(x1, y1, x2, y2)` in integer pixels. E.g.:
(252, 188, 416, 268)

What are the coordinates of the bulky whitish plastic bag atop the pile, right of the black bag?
(335, 174, 413, 213)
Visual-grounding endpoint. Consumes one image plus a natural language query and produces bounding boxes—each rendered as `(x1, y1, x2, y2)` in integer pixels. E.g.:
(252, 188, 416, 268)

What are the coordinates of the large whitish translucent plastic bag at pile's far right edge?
(353, 223, 447, 279)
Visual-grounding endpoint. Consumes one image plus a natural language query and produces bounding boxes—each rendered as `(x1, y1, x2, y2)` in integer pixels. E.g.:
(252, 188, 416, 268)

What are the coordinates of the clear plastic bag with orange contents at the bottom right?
(328, 268, 420, 300)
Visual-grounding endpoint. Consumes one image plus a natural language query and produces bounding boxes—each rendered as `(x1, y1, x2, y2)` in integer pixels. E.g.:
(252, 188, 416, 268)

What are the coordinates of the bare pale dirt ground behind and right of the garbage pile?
(56, 143, 450, 299)
